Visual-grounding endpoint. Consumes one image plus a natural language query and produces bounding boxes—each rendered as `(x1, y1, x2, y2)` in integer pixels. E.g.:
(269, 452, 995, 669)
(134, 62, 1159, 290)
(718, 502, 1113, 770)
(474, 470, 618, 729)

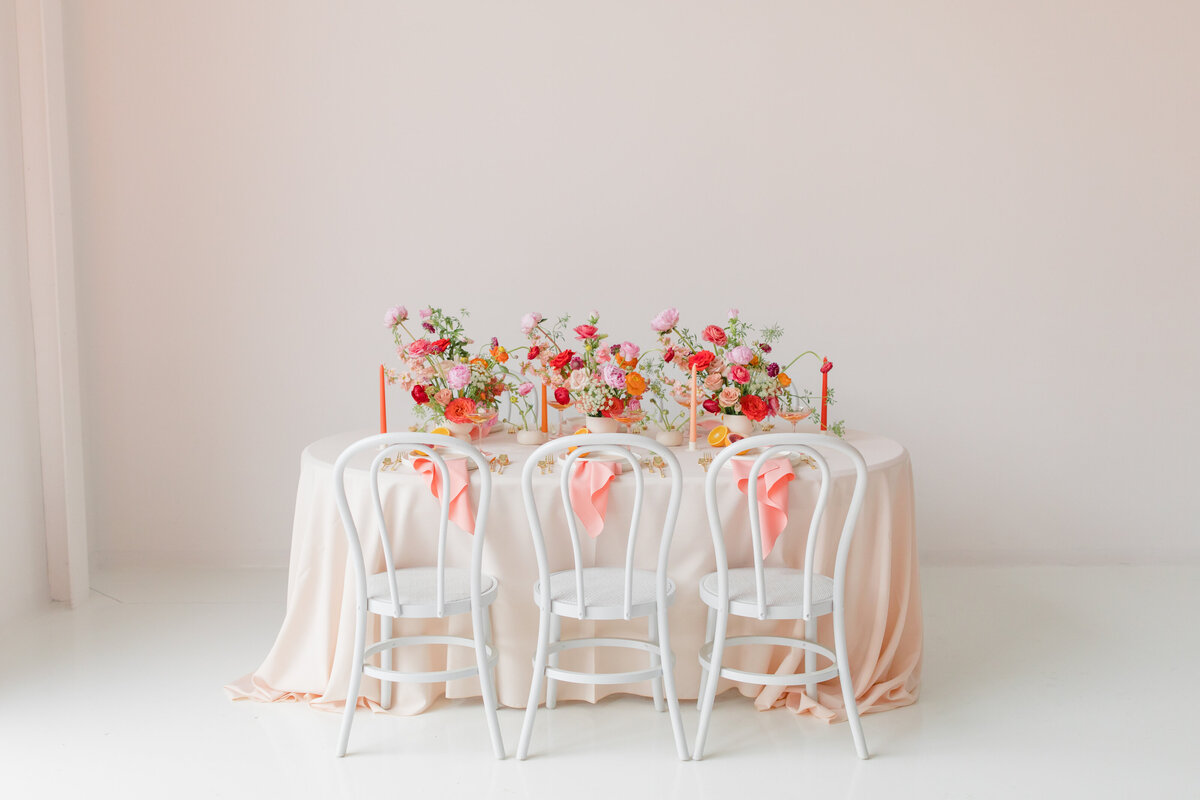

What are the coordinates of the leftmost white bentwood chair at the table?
(334, 433, 504, 758)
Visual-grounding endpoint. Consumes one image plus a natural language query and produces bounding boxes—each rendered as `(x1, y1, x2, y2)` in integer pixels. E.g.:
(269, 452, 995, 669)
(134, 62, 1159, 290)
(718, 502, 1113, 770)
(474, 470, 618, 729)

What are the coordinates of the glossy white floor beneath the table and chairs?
(0, 567, 1200, 800)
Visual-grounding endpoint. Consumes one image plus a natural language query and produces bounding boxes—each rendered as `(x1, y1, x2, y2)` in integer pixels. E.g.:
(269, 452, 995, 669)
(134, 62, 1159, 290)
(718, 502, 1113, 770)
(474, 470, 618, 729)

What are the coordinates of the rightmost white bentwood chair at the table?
(692, 433, 869, 760)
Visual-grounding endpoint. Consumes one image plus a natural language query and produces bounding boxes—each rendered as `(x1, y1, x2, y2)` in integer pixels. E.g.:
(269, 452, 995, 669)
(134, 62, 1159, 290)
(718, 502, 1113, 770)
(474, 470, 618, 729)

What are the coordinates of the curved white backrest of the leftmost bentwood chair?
(334, 432, 492, 616)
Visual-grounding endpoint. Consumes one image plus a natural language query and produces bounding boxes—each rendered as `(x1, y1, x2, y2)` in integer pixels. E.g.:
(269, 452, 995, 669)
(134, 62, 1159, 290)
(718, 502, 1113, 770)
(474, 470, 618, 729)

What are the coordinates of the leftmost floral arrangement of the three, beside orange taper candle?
(384, 306, 510, 423)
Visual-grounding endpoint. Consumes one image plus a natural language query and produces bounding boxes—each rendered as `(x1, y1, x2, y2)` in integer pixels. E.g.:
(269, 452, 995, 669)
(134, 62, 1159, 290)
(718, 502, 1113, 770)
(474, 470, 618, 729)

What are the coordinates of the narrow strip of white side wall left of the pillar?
(0, 0, 49, 620)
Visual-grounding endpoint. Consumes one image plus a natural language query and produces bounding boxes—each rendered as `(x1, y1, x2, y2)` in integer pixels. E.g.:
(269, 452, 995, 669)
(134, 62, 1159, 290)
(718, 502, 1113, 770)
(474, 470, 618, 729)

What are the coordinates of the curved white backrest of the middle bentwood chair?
(521, 433, 683, 619)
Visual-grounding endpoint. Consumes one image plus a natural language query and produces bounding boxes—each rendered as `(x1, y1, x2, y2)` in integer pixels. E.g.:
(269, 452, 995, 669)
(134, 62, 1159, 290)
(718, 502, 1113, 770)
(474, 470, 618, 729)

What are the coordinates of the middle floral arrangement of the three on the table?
(521, 312, 647, 416)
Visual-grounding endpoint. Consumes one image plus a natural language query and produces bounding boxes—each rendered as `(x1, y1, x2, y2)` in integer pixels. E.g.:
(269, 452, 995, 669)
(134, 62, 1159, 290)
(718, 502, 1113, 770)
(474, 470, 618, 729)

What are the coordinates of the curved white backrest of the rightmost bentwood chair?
(704, 433, 866, 620)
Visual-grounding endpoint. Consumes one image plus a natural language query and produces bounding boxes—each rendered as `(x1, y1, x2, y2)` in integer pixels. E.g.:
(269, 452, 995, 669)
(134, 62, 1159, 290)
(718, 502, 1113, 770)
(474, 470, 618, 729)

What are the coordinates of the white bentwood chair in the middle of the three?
(517, 433, 688, 760)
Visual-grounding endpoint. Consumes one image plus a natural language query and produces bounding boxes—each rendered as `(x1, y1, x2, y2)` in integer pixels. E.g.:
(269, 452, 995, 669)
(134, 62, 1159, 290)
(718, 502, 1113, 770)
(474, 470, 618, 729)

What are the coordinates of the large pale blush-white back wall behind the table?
(65, 0, 1200, 563)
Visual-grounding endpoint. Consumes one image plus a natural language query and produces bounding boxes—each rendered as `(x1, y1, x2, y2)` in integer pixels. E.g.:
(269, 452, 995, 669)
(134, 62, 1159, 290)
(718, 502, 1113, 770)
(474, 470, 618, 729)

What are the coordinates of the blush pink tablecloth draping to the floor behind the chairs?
(226, 432, 922, 721)
